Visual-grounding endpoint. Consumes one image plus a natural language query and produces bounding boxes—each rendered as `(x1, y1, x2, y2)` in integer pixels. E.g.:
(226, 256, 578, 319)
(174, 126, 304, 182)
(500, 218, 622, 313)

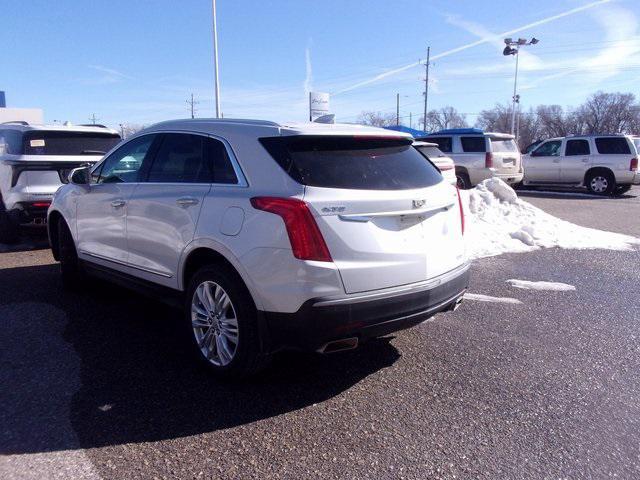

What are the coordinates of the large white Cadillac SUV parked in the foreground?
(48, 119, 469, 376)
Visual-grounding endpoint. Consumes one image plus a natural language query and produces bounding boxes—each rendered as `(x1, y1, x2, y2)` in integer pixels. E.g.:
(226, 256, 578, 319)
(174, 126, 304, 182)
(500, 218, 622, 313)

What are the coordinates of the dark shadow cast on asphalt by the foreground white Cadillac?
(0, 265, 400, 453)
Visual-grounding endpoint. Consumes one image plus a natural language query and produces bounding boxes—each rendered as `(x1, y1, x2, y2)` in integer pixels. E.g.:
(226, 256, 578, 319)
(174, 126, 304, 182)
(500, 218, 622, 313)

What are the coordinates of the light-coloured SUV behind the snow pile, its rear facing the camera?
(417, 128, 523, 189)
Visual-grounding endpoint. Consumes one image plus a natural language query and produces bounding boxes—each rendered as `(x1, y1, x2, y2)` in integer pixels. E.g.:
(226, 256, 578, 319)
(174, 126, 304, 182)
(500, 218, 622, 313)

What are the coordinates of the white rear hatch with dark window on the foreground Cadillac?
(261, 135, 464, 293)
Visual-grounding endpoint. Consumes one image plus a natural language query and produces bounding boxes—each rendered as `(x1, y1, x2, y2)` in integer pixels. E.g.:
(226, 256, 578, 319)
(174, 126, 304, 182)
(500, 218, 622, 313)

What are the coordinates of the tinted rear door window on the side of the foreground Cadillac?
(147, 133, 211, 183)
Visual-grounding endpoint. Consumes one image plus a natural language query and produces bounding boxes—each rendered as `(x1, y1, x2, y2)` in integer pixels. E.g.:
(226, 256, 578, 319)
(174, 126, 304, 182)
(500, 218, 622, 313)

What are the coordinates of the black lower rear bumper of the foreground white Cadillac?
(263, 264, 469, 352)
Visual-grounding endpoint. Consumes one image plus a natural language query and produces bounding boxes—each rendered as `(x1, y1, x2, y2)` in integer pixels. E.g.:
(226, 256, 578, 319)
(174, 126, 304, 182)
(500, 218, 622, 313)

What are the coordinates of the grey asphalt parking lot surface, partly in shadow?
(0, 187, 640, 479)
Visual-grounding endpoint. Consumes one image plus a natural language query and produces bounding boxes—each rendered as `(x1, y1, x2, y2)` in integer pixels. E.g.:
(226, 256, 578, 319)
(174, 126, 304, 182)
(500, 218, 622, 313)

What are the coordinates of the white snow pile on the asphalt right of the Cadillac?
(460, 178, 640, 258)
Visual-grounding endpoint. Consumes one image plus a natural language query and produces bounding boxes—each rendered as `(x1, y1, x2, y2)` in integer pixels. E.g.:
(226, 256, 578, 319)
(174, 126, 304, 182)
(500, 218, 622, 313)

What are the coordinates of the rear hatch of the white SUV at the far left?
(5, 130, 120, 194)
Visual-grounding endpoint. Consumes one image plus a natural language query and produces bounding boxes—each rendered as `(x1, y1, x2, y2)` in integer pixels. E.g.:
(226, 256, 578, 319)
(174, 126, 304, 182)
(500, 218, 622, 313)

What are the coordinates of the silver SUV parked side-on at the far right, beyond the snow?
(522, 135, 640, 195)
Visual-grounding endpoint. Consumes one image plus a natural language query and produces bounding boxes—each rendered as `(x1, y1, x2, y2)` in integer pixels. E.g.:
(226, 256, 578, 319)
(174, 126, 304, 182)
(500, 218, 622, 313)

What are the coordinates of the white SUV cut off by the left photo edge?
(0, 122, 120, 243)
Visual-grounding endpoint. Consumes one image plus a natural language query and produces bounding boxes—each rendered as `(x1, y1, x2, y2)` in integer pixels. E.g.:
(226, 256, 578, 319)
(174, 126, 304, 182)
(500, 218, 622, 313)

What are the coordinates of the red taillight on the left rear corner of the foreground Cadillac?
(251, 197, 332, 262)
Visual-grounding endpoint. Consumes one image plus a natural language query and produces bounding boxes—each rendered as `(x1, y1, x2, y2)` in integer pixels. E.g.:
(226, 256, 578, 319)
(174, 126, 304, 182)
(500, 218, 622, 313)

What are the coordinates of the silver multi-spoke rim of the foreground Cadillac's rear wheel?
(191, 281, 238, 366)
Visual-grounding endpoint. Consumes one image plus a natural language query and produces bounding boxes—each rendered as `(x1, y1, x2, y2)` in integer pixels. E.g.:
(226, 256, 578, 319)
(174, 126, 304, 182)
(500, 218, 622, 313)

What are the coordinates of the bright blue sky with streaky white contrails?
(0, 0, 640, 126)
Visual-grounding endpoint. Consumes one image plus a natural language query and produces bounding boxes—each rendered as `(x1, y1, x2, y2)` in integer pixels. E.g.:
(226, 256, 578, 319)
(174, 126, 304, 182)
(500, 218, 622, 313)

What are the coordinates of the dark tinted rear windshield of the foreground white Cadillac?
(260, 135, 442, 190)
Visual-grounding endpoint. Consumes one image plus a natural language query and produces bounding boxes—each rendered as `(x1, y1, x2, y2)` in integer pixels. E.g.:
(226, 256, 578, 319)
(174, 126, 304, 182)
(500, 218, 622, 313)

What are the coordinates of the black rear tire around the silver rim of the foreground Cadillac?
(183, 264, 269, 379)
